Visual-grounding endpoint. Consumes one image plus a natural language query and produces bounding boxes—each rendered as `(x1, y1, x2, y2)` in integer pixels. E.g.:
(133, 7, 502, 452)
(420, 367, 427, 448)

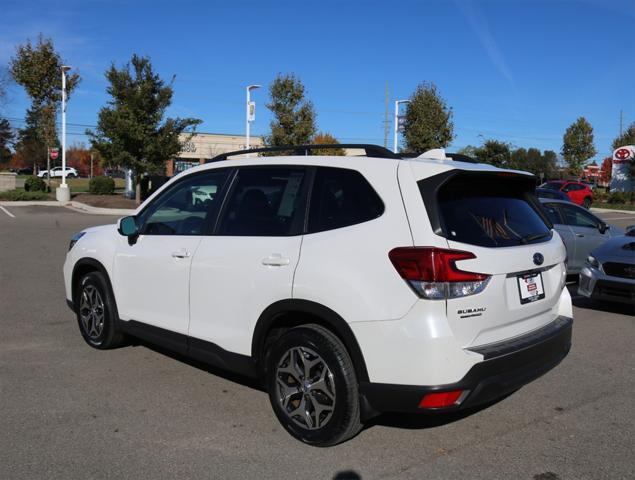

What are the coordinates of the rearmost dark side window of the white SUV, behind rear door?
(309, 167, 384, 233)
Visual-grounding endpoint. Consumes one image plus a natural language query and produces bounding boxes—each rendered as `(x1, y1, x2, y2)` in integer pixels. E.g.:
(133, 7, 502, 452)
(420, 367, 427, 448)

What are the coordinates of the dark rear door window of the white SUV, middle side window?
(218, 167, 306, 236)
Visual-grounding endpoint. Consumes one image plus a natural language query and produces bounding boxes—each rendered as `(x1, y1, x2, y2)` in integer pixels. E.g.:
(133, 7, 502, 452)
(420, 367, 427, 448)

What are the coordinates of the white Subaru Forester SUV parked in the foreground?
(64, 145, 573, 446)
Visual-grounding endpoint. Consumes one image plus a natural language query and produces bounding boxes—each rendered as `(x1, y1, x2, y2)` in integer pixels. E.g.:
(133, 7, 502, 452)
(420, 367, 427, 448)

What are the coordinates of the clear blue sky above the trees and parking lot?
(0, 0, 635, 158)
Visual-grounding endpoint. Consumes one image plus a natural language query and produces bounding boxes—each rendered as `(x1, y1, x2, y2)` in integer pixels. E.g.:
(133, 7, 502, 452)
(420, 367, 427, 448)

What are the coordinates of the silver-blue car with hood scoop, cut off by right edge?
(578, 228, 635, 308)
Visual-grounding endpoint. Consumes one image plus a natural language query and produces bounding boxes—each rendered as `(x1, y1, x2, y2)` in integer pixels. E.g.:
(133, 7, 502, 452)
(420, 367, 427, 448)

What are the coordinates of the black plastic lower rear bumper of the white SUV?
(359, 316, 573, 417)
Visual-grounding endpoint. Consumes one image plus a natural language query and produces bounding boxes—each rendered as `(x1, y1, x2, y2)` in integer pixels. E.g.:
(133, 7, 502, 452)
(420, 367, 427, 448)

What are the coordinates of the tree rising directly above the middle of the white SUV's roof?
(264, 74, 316, 147)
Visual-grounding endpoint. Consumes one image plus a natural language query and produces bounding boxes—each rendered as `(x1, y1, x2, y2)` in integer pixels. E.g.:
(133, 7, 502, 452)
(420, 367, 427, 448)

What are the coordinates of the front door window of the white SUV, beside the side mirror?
(140, 170, 228, 235)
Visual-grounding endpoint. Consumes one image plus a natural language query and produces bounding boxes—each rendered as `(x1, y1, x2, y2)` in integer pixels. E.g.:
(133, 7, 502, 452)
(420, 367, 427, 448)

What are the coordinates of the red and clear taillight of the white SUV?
(388, 247, 490, 300)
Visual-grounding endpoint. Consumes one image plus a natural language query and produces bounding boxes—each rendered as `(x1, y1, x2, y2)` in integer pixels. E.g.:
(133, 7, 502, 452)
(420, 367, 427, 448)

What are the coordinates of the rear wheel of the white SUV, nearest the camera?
(267, 324, 362, 447)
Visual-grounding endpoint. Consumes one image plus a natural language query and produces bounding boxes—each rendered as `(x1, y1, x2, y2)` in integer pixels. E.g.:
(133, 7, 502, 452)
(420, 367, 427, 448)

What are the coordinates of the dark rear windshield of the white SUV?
(428, 176, 551, 247)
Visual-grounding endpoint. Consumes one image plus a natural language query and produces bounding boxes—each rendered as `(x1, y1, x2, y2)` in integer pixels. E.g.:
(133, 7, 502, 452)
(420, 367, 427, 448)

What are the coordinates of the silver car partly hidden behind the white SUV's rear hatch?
(540, 198, 624, 275)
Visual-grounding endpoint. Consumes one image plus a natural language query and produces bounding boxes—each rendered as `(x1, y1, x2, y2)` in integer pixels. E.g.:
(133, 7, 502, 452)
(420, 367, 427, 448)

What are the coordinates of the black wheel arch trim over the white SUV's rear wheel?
(251, 299, 368, 382)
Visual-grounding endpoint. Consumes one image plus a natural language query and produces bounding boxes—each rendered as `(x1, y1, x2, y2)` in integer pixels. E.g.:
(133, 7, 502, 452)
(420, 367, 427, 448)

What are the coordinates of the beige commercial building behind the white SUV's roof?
(165, 133, 263, 177)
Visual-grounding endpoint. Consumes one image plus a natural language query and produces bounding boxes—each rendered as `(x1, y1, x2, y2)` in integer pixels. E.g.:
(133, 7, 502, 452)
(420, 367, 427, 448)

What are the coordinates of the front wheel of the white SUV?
(75, 272, 126, 350)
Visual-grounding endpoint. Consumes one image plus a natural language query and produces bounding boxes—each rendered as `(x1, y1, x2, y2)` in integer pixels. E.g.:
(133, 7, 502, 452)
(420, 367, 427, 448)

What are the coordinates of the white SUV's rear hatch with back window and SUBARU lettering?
(418, 170, 566, 347)
